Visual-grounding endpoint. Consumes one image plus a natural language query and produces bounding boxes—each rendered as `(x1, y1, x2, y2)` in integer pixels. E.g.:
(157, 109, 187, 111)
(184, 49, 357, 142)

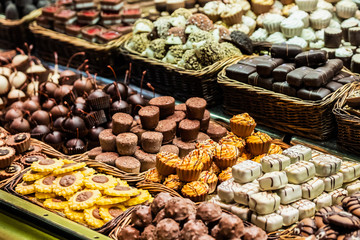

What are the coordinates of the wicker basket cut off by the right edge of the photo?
(333, 83, 360, 154)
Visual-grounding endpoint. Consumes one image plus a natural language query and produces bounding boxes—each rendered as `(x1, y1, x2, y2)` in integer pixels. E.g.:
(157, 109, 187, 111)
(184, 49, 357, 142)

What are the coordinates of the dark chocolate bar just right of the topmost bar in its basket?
(295, 50, 328, 67)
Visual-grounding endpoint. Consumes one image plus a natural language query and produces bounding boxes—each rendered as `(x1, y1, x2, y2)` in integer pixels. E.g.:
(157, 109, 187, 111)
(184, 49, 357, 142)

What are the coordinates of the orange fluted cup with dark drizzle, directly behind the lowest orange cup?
(176, 152, 206, 182)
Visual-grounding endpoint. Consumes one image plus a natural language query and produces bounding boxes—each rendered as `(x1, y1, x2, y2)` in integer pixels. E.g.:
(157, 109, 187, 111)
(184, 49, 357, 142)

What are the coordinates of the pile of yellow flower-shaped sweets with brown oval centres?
(15, 157, 152, 228)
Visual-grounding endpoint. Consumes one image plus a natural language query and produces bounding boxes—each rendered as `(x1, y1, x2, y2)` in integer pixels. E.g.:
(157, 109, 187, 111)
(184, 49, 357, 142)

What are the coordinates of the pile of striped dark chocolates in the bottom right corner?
(292, 192, 360, 240)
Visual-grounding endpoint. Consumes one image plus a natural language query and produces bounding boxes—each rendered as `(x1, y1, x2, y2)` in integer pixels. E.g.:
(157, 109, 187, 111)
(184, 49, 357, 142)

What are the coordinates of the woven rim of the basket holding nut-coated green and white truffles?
(120, 33, 247, 77)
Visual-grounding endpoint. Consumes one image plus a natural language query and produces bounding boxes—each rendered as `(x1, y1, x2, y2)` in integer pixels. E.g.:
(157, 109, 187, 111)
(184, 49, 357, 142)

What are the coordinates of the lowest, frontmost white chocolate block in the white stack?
(251, 213, 283, 232)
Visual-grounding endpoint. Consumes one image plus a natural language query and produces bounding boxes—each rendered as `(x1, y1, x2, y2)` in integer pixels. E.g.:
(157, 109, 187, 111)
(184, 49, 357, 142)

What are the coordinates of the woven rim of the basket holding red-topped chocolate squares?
(29, 21, 126, 51)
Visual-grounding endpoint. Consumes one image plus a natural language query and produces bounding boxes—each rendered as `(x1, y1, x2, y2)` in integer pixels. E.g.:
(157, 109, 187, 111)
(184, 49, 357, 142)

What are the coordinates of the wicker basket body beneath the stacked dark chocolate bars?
(218, 58, 350, 140)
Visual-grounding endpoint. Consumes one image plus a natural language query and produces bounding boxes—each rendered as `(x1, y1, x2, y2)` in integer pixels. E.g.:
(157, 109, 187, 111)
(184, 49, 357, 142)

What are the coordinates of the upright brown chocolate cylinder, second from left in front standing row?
(116, 133, 138, 156)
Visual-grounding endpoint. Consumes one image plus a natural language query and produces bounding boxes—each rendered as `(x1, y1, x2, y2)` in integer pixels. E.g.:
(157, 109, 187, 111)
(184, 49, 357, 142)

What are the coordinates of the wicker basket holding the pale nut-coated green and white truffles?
(120, 33, 242, 105)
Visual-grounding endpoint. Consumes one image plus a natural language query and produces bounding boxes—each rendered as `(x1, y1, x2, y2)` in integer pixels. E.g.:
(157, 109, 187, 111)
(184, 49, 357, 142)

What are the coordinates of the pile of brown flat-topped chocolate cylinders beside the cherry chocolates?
(88, 96, 231, 173)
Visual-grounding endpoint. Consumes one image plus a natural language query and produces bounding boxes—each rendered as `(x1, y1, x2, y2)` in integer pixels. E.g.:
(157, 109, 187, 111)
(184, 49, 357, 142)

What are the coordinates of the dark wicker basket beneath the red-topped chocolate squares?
(29, 22, 125, 77)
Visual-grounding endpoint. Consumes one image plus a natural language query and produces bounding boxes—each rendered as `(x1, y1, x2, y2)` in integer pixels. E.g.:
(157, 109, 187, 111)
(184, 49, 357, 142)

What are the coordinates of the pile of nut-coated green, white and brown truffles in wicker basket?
(127, 8, 253, 70)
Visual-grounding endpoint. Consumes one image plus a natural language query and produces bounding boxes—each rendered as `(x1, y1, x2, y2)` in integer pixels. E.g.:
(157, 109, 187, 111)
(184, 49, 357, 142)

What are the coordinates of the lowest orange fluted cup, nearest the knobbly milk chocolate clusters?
(181, 181, 209, 202)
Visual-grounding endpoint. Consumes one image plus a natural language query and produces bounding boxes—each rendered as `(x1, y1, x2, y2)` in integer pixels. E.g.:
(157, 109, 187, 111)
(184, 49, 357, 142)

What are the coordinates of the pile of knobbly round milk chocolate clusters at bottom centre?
(117, 193, 267, 240)
